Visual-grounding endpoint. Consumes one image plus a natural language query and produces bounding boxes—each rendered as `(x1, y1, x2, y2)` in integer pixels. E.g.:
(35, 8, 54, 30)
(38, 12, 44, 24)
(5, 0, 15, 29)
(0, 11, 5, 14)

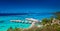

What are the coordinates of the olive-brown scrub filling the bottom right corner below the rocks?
(40, 24, 60, 31)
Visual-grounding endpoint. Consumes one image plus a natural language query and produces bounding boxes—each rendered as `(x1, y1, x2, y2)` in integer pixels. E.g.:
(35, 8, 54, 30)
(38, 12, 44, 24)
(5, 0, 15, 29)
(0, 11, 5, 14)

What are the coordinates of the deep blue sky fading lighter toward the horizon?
(0, 0, 60, 13)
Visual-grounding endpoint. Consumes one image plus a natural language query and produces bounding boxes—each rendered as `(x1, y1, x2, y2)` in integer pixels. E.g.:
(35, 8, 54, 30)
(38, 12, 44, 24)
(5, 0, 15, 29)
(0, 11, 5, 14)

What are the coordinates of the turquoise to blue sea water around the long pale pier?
(0, 14, 53, 31)
